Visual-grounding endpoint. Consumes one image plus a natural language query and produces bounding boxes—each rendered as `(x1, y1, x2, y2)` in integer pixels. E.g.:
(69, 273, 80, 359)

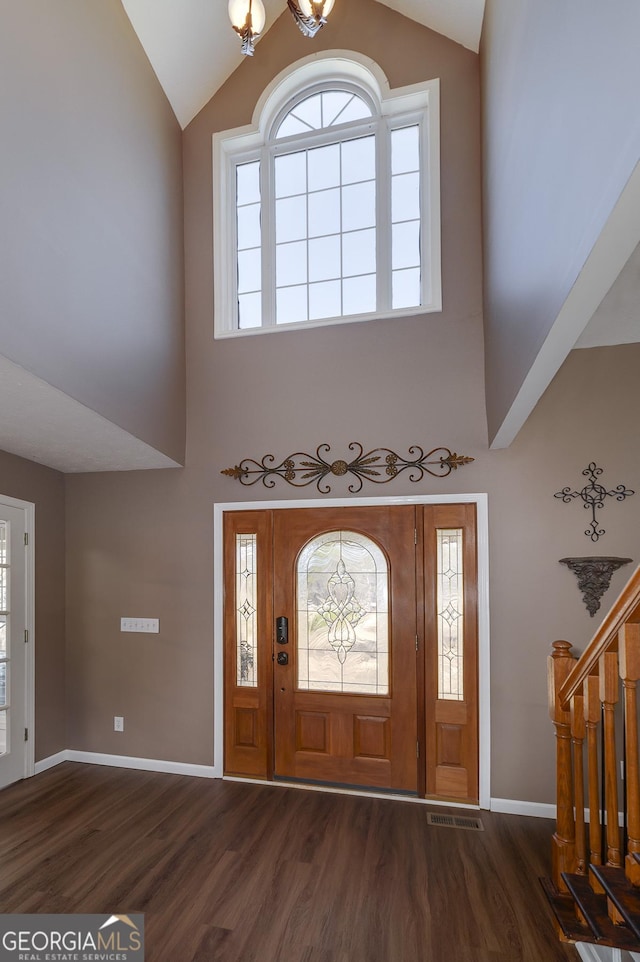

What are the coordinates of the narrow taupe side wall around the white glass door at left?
(0, 451, 67, 761)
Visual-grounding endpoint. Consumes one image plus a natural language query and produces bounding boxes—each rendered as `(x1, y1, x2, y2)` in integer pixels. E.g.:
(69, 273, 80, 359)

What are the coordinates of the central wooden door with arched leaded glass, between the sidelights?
(274, 506, 417, 792)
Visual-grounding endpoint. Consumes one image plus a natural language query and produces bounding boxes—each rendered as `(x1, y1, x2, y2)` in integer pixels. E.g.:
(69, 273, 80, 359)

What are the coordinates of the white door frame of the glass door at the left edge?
(0, 494, 36, 778)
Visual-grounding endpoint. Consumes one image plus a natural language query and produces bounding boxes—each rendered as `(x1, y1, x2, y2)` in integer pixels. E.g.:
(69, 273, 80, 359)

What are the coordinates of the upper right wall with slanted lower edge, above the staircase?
(481, 0, 640, 439)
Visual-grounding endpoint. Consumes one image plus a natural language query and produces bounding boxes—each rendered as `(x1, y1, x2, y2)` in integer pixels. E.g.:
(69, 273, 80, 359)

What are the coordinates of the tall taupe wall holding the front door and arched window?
(66, 0, 640, 802)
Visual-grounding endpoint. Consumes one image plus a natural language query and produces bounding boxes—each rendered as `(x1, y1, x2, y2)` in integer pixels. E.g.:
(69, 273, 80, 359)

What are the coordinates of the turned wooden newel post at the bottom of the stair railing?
(547, 641, 577, 891)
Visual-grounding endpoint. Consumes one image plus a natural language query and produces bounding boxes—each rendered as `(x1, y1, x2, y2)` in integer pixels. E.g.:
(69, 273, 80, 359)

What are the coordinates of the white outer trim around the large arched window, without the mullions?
(212, 51, 442, 338)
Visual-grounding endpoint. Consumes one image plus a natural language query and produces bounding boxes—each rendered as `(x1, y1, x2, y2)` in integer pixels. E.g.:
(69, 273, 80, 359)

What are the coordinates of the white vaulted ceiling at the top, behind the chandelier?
(122, 0, 485, 128)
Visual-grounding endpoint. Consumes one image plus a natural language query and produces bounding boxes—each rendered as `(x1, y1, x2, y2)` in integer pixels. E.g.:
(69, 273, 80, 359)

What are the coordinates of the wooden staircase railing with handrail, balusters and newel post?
(548, 568, 640, 892)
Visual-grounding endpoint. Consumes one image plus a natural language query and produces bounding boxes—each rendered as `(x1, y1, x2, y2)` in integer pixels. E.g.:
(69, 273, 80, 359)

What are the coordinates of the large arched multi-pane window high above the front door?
(214, 57, 440, 336)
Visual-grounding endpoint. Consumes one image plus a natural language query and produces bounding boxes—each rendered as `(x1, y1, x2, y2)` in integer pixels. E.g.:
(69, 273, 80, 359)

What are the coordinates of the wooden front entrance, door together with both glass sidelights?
(224, 504, 478, 802)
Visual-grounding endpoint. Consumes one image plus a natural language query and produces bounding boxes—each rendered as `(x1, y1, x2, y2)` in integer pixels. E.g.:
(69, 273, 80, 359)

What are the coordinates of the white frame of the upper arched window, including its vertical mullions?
(213, 51, 442, 338)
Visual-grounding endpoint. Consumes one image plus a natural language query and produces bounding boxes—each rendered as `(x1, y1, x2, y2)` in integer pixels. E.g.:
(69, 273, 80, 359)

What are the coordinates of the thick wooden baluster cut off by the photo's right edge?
(618, 623, 640, 885)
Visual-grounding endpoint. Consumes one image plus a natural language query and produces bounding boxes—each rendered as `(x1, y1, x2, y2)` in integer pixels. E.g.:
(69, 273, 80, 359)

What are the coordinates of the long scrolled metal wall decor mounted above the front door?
(220, 441, 475, 494)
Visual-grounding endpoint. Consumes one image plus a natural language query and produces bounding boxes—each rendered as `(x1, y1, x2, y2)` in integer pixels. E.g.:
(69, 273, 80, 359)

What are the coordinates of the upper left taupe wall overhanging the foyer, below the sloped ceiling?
(0, 0, 185, 461)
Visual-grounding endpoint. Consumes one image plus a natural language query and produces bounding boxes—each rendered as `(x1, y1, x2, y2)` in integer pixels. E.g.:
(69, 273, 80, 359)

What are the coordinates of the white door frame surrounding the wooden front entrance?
(213, 492, 491, 809)
